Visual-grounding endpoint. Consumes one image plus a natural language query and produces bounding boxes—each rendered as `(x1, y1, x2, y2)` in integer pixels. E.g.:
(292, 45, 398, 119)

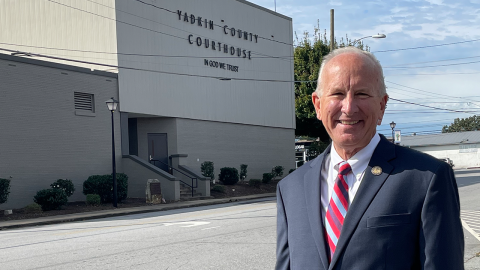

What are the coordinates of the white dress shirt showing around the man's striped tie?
(320, 133, 380, 221)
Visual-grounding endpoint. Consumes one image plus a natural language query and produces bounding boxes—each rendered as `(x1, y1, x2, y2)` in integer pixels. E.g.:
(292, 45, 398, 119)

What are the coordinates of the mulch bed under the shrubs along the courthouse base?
(0, 180, 278, 222)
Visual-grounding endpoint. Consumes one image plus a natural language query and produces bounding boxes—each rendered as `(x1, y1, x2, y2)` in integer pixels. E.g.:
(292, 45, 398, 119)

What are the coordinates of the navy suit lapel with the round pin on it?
(329, 136, 395, 269)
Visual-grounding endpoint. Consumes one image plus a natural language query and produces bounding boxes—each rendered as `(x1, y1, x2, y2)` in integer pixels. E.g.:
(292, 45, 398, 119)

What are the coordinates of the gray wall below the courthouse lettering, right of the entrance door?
(177, 119, 295, 180)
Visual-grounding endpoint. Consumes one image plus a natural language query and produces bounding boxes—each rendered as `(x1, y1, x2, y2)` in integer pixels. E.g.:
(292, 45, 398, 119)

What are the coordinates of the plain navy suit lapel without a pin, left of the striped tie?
(304, 146, 330, 269)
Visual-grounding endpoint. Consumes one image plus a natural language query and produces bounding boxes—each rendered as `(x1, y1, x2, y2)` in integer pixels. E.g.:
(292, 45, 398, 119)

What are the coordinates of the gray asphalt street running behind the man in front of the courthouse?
(0, 170, 480, 270)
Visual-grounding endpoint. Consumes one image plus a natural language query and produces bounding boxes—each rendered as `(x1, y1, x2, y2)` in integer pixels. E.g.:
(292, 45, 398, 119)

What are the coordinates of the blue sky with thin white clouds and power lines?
(249, 0, 480, 136)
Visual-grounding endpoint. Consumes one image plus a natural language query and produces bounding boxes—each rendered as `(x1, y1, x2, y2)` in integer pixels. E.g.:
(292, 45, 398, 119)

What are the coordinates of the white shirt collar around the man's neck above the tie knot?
(330, 133, 380, 176)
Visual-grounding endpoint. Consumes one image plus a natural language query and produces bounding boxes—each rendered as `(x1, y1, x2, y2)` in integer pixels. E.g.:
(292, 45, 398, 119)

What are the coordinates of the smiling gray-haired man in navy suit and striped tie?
(276, 47, 464, 270)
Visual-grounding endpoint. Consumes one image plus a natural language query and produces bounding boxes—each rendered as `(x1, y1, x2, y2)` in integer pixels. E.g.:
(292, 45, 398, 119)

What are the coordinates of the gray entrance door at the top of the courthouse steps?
(147, 133, 168, 172)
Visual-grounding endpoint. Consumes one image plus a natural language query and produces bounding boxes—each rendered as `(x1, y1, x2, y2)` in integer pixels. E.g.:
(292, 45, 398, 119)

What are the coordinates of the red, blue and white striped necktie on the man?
(325, 161, 352, 261)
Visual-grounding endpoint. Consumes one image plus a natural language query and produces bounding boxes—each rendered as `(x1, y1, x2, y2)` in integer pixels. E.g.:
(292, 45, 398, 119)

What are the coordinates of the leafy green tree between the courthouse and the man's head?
(294, 25, 370, 142)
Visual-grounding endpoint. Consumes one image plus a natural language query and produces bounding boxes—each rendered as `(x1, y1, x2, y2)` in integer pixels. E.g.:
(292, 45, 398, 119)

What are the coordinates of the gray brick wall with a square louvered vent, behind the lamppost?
(0, 55, 121, 209)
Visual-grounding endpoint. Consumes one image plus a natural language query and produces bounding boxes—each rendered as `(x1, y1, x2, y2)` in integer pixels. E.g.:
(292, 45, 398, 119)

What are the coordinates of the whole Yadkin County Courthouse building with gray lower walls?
(0, 0, 295, 209)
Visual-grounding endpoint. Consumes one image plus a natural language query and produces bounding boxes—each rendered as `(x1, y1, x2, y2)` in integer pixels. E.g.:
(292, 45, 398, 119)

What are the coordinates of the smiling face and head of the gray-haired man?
(312, 53, 388, 154)
